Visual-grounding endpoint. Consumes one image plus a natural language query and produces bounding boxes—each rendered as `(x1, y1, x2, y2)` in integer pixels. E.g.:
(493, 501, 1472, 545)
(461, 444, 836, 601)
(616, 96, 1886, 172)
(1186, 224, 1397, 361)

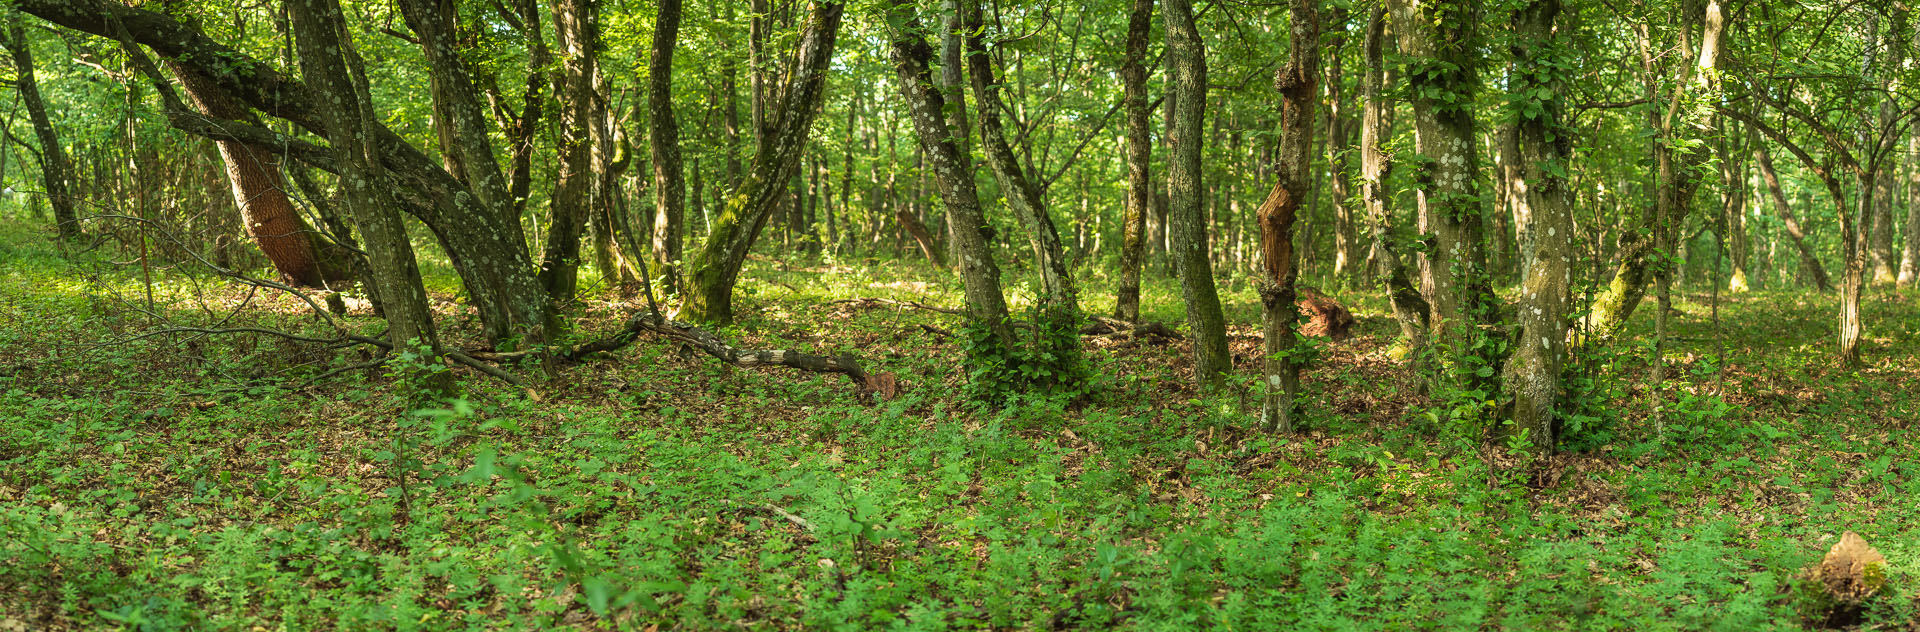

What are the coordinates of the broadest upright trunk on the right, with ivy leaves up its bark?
(1388, 0, 1496, 343)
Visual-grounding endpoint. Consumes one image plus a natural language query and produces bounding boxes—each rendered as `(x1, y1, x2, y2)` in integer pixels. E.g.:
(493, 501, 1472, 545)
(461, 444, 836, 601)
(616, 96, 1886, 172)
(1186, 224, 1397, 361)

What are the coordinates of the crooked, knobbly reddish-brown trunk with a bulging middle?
(1256, 0, 1338, 432)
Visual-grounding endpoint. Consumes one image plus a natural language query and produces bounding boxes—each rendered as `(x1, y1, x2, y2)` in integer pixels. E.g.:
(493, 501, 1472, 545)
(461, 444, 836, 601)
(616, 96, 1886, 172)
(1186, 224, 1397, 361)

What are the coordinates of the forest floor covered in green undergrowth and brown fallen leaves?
(0, 223, 1920, 632)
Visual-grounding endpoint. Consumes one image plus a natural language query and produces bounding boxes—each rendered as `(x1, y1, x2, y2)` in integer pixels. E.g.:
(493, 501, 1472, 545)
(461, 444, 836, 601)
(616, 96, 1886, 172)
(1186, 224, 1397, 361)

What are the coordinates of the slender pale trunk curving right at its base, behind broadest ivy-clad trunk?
(1359, 6, 1428, 351)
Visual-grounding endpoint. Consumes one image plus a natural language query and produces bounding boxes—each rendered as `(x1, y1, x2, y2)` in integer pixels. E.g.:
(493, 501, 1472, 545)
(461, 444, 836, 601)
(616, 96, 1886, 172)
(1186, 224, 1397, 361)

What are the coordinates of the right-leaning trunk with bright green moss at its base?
(680, 2, 847, 325)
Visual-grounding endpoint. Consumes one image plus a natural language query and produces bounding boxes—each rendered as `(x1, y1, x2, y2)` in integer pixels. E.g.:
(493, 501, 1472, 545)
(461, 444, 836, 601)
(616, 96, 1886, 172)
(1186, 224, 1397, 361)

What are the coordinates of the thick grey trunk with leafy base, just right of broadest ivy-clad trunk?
(1501, 0, 1572, 453)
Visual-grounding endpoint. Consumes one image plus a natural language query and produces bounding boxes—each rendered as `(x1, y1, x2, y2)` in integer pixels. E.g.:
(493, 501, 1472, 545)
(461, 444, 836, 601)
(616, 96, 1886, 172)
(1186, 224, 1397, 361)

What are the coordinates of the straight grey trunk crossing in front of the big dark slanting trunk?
(286, 0, 444, 386)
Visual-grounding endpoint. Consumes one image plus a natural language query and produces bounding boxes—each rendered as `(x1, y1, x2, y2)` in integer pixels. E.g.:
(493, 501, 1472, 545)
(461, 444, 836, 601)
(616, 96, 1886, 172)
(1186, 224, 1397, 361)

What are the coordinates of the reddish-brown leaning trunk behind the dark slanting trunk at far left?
(167, 63, 339, 288)
